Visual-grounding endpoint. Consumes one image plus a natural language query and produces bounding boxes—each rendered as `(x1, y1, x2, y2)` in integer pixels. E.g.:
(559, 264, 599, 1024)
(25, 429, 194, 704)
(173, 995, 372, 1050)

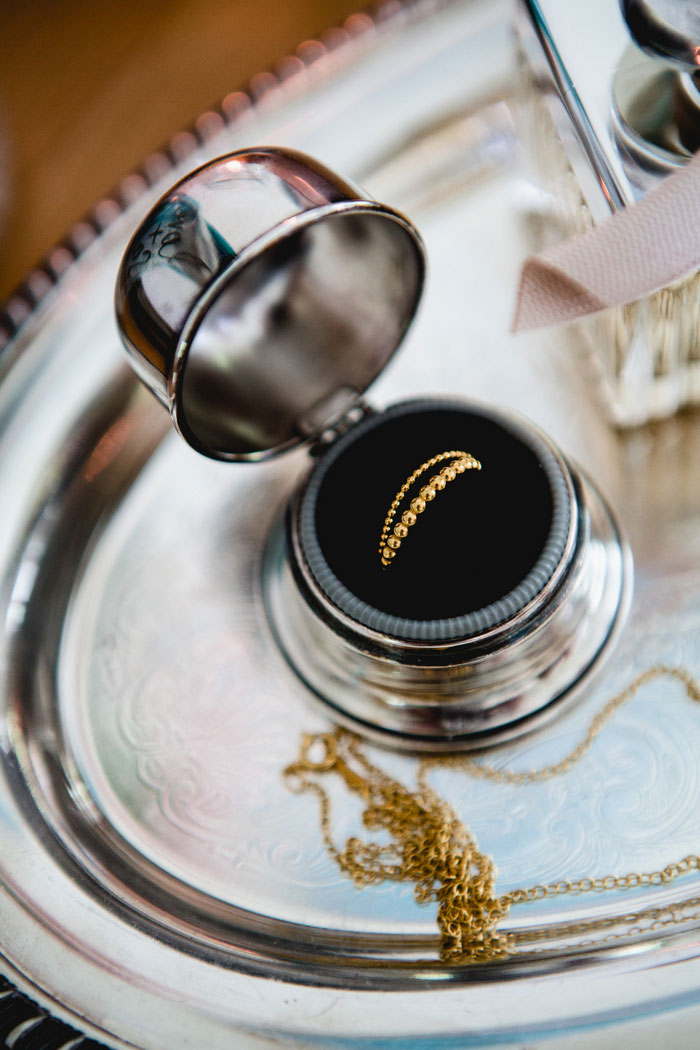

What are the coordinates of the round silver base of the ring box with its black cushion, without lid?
(264, 399, 632, 750)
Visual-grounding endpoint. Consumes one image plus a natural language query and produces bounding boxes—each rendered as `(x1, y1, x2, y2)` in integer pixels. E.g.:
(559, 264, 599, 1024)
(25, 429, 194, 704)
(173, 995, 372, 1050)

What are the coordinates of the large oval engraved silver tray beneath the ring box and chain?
(0, 0, 700, 1050)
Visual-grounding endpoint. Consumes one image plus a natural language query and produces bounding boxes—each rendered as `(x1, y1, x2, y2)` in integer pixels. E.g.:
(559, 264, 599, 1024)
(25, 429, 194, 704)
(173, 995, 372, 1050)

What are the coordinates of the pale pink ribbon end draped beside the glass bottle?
(513, 153, 700, 332)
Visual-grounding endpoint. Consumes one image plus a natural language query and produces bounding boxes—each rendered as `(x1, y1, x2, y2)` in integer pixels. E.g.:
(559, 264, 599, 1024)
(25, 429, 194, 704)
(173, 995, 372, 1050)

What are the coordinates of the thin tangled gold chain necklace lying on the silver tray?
(284, 666, 700, 963)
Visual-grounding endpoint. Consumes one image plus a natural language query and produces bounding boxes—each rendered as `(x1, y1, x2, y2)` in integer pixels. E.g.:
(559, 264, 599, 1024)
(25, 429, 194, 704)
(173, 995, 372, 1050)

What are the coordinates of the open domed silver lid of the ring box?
(116, 148, 424, 460)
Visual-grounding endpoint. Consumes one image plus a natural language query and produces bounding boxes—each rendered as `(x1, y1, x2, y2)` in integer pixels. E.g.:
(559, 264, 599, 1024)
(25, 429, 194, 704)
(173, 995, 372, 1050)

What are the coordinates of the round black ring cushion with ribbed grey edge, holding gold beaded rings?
(299, 400, 573, 643)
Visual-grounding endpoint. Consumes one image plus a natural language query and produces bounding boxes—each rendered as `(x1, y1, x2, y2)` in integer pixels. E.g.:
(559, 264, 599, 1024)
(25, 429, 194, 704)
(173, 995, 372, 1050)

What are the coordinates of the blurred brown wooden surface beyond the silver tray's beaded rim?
(0, 0, 362, 300)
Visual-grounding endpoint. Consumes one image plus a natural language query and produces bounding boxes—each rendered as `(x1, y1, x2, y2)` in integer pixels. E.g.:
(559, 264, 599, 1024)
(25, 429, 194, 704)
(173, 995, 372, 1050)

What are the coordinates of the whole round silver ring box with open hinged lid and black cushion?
(116, 148, 631, 750)
